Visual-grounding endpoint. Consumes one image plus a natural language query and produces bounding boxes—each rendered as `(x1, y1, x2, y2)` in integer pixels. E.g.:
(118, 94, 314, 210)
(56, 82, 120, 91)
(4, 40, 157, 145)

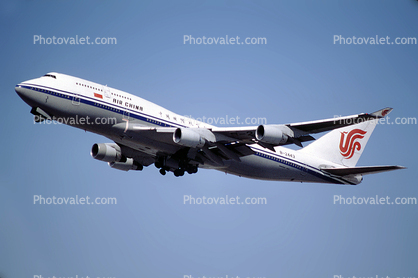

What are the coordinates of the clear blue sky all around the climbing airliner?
(0, 0, 418, 278)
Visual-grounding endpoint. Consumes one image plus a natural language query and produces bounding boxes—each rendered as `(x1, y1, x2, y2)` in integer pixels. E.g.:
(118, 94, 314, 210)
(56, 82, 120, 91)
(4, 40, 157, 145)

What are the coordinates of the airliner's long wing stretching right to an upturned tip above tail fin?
(108, 108, 392, 165)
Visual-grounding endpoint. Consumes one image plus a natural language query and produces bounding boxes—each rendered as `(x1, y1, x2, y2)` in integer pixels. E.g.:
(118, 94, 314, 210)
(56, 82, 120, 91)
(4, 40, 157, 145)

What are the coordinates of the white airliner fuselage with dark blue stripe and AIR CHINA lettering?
(16, 73, 355, 184)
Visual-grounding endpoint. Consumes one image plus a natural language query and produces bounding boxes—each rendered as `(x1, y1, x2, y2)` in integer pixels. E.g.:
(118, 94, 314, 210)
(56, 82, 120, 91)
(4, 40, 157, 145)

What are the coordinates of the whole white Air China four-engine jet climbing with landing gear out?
(15, 72, 405, 185)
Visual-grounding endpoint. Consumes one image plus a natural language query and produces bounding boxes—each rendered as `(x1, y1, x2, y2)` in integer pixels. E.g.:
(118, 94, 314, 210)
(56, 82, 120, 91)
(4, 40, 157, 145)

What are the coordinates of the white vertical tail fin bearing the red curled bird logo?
(299, 120, 377, 167)
